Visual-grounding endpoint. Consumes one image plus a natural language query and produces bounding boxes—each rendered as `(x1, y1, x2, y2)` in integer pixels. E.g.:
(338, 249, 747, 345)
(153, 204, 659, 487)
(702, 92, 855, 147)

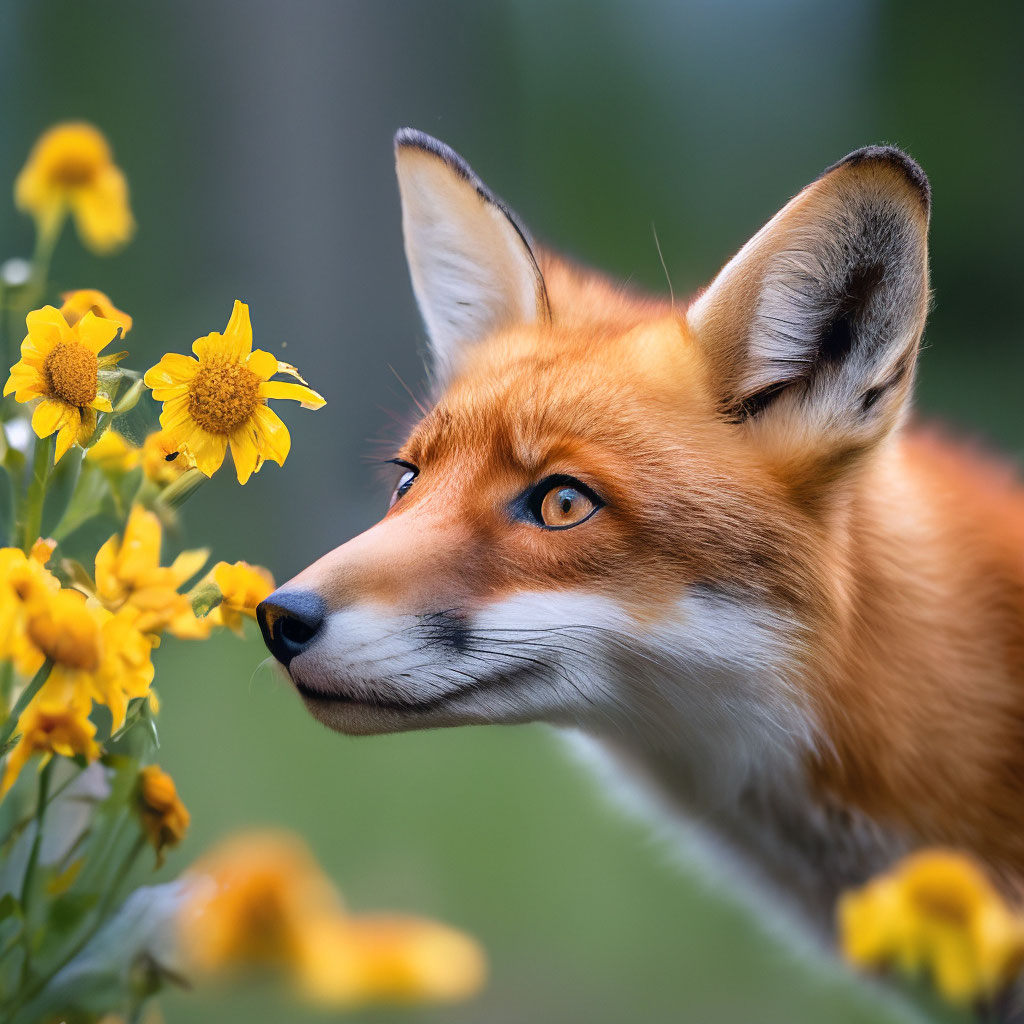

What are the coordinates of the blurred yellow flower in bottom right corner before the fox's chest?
(839, 850, 1024, 1006)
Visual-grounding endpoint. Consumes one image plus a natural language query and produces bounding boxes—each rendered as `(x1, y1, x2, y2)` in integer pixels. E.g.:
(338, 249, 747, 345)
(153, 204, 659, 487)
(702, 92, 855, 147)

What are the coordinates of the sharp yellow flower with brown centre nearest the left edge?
(3, 306, 120, 462)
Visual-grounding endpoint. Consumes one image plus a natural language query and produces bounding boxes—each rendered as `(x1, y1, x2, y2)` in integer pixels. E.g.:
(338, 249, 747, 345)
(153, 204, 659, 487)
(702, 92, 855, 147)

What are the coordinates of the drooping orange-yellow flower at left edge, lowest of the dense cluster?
(0, 680, 99, 797)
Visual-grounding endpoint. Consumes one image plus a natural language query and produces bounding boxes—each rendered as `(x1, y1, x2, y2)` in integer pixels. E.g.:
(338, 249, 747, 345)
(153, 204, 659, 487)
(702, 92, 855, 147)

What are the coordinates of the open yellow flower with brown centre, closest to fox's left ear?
(144, 300, 324, 483)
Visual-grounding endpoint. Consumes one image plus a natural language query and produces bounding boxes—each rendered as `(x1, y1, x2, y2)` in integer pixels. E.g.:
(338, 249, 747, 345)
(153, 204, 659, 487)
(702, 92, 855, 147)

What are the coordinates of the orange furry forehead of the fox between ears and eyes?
(402, 316, 726, 473)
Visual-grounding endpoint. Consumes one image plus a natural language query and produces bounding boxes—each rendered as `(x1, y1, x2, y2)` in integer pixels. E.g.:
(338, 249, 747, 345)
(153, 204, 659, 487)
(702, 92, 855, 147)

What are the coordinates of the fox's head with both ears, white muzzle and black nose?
(258, 130, 930, 790)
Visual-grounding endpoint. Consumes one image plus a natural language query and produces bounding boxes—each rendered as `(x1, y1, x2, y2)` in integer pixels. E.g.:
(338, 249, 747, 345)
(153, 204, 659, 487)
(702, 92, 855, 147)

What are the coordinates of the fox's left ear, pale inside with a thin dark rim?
(394, 128, 549, 382)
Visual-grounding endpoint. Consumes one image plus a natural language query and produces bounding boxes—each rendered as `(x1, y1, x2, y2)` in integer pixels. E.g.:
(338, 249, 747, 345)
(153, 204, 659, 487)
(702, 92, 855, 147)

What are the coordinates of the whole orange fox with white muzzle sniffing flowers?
(257, 129, 1024, 942)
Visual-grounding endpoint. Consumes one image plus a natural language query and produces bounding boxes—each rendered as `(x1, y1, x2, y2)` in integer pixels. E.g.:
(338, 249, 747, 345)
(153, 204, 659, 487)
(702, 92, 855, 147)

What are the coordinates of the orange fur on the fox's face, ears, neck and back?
(271, 136, 1024, 913)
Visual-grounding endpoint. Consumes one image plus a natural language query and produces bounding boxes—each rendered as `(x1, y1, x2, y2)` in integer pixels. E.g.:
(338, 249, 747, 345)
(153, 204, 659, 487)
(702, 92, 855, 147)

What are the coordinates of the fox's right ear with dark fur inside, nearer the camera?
(687, 146, 931, 491)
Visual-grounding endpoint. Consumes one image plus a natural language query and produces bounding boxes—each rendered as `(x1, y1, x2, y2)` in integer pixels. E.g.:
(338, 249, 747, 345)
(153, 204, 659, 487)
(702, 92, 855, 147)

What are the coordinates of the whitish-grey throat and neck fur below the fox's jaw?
(569, 591, 906, 935)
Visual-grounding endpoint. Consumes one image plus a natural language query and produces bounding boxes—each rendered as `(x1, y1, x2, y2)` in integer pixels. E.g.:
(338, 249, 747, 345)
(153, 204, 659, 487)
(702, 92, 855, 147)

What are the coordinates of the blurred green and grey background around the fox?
(0, 0, 1024, 1024)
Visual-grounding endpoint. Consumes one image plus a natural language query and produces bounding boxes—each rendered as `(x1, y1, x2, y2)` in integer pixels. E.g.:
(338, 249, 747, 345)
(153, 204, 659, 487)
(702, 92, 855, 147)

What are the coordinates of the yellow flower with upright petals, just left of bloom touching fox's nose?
(96, 505, 211, 638)
